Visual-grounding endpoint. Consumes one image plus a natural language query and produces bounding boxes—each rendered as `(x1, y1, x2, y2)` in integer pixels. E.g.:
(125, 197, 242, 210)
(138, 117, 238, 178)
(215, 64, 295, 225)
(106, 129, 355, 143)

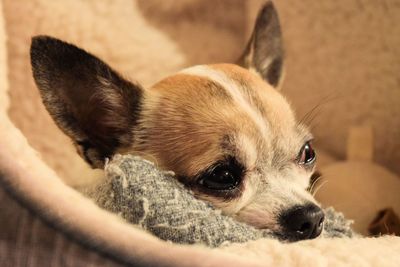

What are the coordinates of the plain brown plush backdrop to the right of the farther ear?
(247, 0, 400, 173)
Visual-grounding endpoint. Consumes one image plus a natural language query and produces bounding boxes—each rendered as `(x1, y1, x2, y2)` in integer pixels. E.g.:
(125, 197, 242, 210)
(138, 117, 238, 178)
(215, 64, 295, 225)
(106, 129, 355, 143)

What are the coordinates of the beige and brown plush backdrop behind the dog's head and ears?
(3, 0, 400, 185)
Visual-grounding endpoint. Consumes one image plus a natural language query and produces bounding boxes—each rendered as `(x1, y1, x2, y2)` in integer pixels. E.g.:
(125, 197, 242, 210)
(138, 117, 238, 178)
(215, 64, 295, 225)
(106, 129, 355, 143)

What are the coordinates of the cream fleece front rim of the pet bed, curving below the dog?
(0, 2, 400, 266)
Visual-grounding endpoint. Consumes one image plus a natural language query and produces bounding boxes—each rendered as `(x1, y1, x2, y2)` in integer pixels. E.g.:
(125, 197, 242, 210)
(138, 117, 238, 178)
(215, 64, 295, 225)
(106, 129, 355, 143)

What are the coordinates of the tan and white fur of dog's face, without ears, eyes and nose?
(117, 64, 315, 230)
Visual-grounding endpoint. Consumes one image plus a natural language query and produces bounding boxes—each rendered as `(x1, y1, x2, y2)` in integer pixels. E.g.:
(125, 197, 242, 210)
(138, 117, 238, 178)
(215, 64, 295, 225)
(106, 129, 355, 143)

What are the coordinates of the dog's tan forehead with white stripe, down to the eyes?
(143, 64, 300, 173)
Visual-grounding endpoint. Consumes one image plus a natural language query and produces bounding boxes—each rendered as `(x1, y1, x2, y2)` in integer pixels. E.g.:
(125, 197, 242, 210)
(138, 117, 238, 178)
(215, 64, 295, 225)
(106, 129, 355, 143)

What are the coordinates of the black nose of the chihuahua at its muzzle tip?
(280, 204, 325, 241)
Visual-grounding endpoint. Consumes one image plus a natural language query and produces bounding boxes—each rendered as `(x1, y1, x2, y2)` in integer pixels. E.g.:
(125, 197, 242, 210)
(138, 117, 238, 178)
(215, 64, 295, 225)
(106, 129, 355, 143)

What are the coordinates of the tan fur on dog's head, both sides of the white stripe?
(133, 64, 310, 176)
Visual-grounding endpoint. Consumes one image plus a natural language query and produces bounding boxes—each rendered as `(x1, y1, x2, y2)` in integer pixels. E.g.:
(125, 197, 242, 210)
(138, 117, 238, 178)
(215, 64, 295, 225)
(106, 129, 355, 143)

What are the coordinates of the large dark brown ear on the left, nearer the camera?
(31, 36, 143, 168)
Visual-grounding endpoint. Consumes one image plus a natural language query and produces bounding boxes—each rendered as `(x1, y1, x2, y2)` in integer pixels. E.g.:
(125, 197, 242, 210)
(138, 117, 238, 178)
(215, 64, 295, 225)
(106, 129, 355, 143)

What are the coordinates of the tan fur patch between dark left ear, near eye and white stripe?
(133, 71, 242, 176)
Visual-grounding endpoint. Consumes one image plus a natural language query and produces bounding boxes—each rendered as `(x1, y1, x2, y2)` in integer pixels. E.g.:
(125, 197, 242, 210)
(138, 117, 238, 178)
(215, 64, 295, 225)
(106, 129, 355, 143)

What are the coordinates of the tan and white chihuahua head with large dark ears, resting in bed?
(31, 2, 324, 241)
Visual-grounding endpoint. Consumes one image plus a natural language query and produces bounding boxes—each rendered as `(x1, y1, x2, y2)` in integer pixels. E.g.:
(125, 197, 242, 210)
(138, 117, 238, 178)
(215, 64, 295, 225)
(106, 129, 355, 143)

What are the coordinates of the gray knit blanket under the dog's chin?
(97, 155, 353, 247)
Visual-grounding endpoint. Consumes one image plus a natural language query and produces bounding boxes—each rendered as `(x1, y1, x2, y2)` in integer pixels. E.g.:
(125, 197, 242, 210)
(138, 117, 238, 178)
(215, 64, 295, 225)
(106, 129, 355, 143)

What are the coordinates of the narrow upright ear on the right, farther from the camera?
(237, 1, 284, 87)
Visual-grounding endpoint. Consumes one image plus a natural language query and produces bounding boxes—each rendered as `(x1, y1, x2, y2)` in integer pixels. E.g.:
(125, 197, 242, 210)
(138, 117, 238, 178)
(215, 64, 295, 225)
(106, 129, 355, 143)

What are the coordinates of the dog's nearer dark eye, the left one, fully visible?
(198, 159, 243, 190)
